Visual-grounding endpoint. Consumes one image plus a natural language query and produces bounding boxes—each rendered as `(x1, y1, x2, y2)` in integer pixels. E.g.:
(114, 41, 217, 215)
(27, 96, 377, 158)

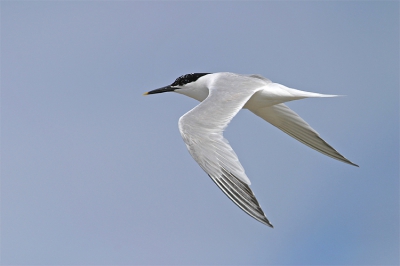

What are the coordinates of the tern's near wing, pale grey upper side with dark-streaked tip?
(179, 73, 272, 227)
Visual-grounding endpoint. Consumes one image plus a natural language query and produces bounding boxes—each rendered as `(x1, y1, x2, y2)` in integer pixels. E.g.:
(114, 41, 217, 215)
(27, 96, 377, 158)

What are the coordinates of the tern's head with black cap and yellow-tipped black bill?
(143, 73, 211, 101)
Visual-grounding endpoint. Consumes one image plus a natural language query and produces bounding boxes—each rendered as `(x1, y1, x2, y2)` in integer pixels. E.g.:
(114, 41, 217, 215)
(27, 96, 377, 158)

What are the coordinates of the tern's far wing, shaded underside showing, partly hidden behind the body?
(251, 104, 358, 166)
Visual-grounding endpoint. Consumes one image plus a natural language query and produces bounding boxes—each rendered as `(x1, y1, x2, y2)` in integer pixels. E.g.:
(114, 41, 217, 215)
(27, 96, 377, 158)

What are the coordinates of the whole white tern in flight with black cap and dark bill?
(144, 72, 358, 227)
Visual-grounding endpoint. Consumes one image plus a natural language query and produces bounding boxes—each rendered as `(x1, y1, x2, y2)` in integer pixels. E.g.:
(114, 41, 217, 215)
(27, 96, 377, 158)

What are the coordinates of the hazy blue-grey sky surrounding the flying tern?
(1, 1, 399, 265)
